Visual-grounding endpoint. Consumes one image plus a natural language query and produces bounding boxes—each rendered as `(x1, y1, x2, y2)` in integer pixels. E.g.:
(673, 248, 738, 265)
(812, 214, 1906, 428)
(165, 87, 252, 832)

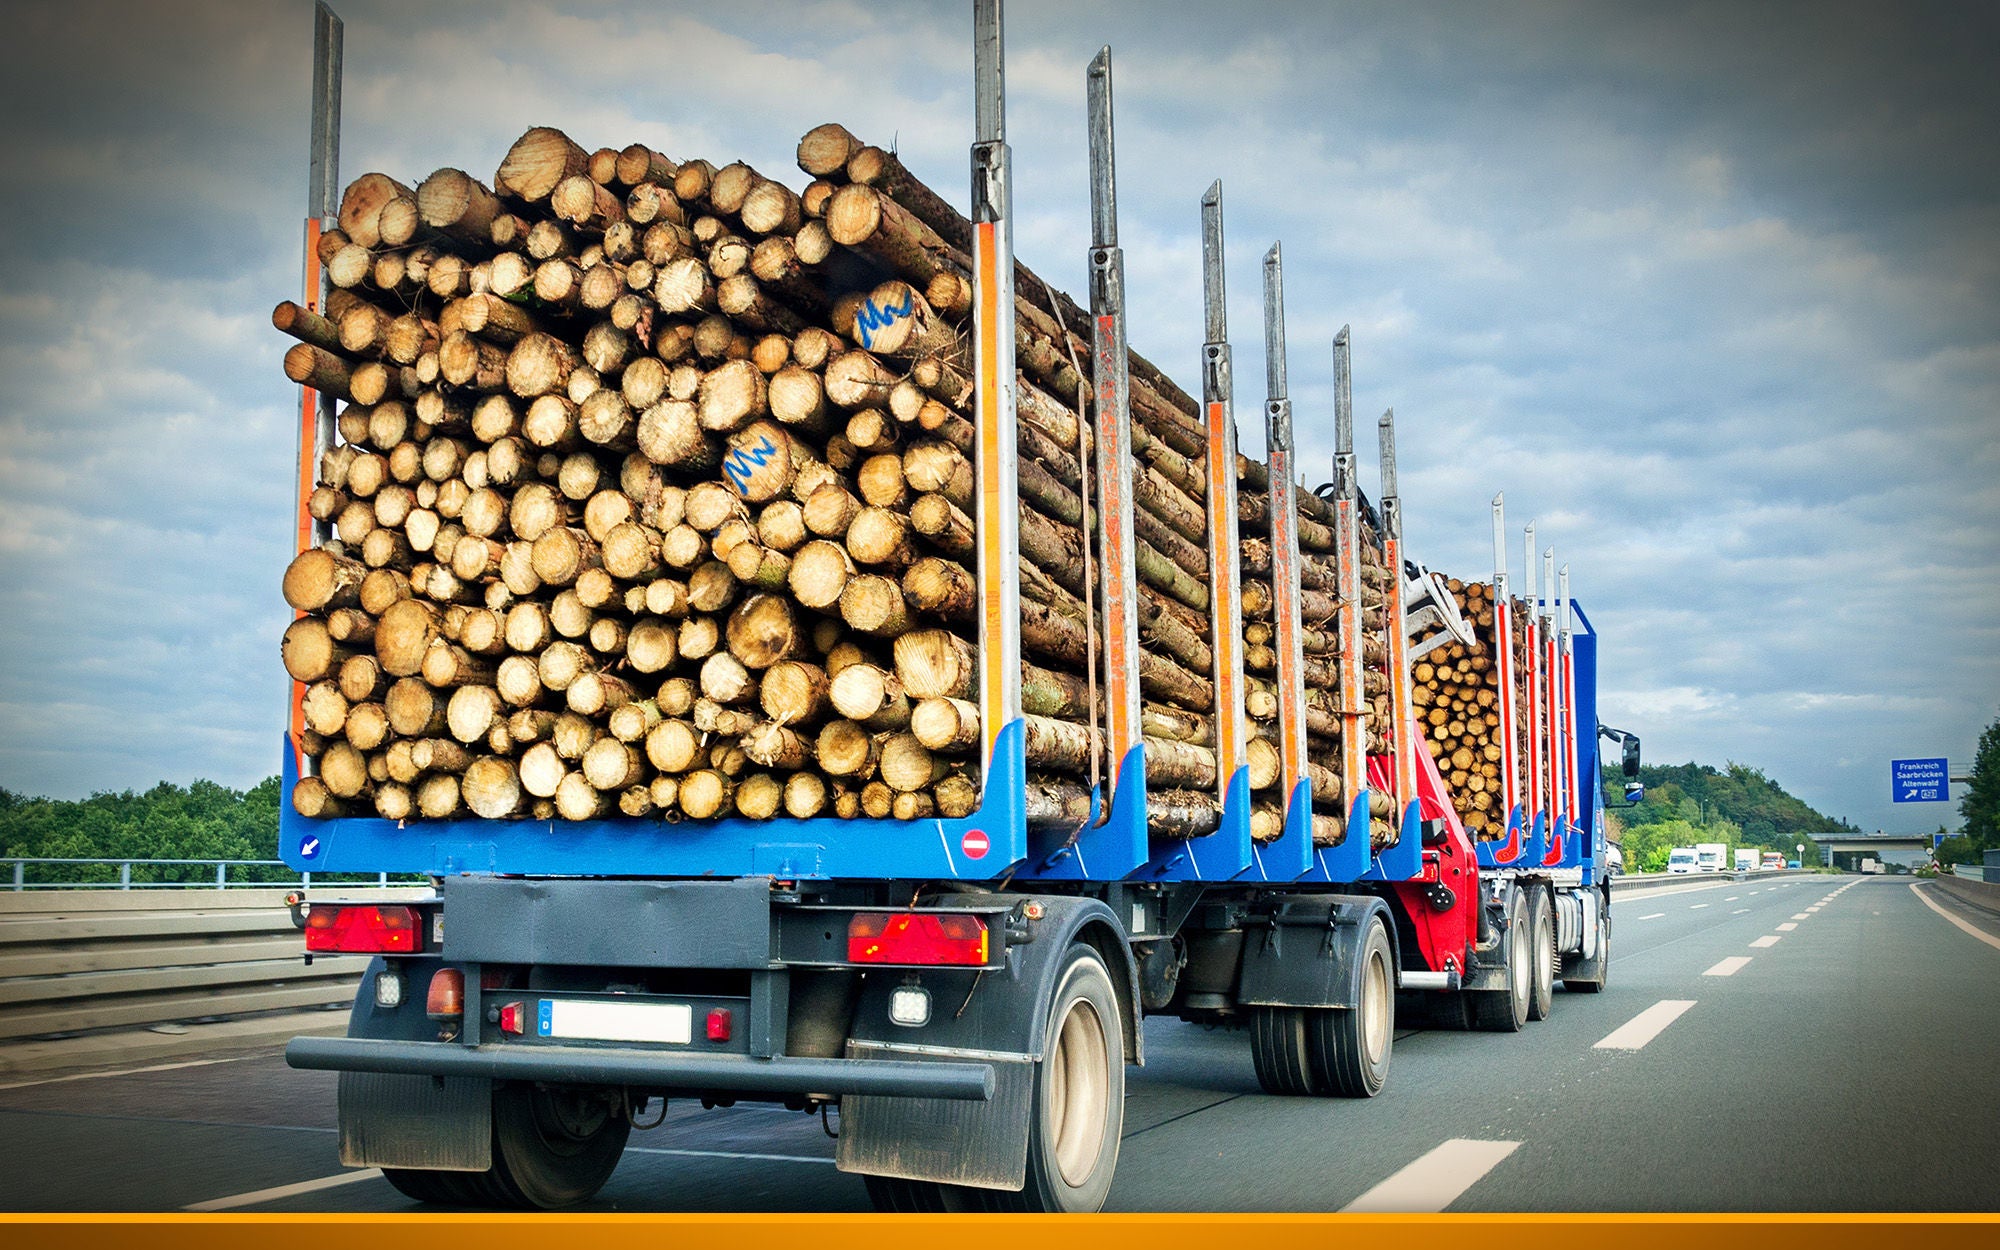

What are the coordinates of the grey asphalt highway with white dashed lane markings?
(0, 876, 2000, 1212)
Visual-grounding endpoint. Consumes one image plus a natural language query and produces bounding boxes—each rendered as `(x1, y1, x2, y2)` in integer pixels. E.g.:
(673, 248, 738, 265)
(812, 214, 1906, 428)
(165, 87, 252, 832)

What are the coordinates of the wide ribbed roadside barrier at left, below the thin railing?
(0, 886, 422, 1042)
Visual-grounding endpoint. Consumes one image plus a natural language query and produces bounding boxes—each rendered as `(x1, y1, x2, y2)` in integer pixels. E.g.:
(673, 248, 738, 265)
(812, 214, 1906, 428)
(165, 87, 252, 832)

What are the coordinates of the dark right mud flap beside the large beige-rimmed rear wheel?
(834, 1040, 1036, 1190)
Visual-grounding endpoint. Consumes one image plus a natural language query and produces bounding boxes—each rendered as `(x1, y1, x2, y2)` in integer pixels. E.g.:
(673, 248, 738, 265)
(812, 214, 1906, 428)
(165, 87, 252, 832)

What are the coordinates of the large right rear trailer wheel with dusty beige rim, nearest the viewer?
(972, 942, 1124, 1214)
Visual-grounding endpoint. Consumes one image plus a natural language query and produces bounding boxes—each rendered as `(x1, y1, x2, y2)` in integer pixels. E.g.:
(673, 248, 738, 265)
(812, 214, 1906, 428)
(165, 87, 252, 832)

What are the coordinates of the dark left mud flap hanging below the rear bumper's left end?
(340, 1072, 494, 1172)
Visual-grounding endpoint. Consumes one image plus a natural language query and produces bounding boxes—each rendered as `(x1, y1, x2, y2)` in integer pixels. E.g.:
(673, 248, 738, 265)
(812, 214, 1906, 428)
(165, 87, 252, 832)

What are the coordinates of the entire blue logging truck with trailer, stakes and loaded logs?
(274, 0, 1638, 1212)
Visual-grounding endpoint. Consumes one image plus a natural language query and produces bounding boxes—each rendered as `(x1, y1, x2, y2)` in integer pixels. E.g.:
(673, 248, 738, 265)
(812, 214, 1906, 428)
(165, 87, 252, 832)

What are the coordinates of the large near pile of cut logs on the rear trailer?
(274, 124, 1386, 840)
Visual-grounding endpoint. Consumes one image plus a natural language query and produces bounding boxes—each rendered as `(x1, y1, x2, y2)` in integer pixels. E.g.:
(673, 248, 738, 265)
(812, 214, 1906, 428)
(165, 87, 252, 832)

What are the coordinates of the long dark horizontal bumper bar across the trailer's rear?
(284, 1038, 994, 1102)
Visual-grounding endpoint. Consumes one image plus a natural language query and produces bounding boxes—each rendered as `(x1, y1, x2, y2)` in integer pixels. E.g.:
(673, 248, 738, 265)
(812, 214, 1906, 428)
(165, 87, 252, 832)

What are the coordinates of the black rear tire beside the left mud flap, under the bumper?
(482, 1082, 632, 1210)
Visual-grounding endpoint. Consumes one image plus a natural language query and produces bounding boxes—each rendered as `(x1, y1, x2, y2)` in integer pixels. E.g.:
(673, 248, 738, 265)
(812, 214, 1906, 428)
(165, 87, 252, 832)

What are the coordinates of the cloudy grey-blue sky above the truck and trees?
(0, 0, 2000, 830)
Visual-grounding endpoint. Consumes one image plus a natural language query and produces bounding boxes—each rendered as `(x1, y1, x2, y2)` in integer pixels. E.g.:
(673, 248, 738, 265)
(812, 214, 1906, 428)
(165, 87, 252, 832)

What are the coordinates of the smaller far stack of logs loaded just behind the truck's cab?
(1410, 578, 1506, 838)
